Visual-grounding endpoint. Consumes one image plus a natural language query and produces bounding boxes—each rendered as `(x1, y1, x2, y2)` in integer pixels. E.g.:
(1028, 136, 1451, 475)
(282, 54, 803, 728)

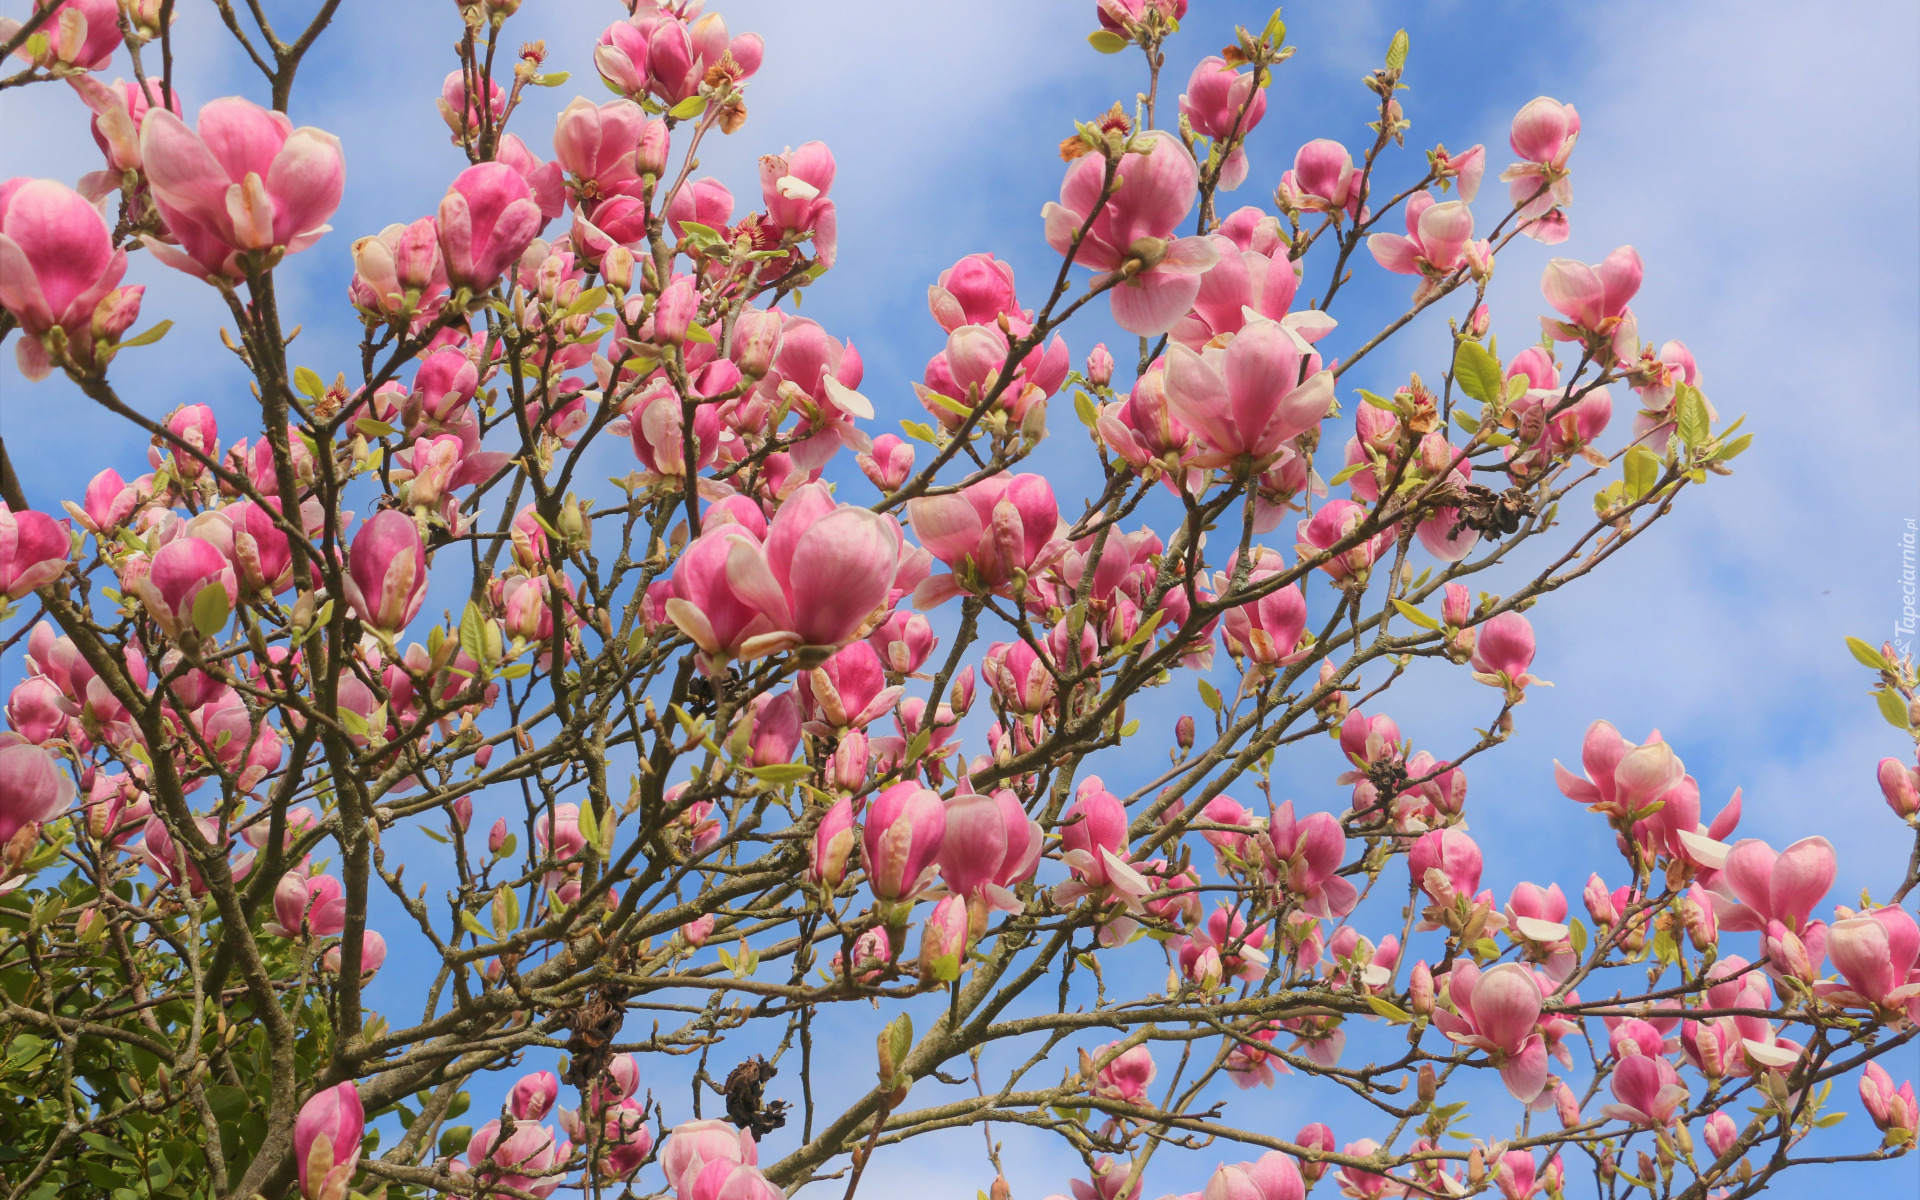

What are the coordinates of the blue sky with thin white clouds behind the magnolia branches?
(0, 0, 1920, 1196)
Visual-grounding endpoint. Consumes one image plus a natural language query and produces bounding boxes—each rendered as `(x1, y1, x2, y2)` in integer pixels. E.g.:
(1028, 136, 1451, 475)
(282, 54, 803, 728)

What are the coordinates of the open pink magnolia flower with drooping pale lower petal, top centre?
(1041, 129, 1219, 338)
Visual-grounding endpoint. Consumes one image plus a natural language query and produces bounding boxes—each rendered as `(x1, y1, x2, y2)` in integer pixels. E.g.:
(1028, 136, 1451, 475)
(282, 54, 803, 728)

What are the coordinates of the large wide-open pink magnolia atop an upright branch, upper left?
(140, 96, 346, 278)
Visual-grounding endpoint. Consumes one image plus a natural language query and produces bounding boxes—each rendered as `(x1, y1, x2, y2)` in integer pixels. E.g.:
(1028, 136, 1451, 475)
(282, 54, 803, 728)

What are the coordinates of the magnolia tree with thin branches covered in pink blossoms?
(0, 0, 1920, 1200)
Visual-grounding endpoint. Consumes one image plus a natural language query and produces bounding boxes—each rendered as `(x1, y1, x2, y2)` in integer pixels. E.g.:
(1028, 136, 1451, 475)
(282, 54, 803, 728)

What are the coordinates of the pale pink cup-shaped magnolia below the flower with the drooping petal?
(1165, 317, 1332, 468)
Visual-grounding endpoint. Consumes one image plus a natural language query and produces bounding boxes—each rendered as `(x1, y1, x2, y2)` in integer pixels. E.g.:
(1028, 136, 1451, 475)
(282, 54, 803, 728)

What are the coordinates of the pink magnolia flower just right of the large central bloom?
(906, 474, 1066, 609)
